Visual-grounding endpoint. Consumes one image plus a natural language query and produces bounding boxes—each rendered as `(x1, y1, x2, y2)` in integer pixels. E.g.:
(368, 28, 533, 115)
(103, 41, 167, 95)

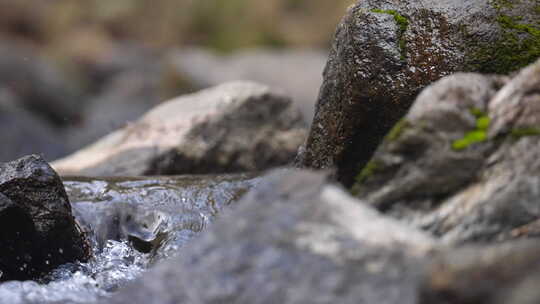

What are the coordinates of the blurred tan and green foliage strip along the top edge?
(0, 0, 353, 52)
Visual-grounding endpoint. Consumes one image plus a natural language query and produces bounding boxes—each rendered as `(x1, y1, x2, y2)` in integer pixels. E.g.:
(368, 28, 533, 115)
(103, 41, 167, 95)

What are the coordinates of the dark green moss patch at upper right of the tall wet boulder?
(471, 0, 540, 74)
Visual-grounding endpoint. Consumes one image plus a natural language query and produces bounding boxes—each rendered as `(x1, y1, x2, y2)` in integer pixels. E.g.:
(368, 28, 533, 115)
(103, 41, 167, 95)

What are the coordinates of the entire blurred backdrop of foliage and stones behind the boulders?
(0, 0, 354, 161)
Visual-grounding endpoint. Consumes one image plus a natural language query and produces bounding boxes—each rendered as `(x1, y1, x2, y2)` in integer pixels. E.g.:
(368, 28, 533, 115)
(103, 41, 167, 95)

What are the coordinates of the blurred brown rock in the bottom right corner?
(418, 241, 540, 304)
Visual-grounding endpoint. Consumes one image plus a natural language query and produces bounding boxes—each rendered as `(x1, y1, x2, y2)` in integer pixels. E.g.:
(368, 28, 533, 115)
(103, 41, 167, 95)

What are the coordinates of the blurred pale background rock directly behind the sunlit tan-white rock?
(165, 48, 326, 122)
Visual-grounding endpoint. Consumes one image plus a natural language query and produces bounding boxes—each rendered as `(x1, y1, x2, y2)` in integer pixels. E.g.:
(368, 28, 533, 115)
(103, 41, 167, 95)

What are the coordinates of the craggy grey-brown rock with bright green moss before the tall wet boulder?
(353, 61, 540, 243)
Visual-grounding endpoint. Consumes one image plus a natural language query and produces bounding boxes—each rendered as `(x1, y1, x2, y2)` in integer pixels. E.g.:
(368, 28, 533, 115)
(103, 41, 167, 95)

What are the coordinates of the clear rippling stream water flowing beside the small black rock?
(0, 175, 259, 304)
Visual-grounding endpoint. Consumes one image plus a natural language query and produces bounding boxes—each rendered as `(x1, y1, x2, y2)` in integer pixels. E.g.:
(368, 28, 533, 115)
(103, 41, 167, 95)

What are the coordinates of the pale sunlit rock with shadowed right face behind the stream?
(53, 82, 306, 176)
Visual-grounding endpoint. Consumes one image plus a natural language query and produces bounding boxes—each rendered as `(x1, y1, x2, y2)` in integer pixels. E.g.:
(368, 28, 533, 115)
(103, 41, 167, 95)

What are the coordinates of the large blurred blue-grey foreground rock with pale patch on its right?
(104, 171, 436, 304)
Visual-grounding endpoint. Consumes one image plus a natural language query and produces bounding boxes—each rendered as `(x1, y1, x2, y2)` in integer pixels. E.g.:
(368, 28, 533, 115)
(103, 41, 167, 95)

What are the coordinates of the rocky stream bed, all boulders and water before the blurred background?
(0, 0, 540, 304)
